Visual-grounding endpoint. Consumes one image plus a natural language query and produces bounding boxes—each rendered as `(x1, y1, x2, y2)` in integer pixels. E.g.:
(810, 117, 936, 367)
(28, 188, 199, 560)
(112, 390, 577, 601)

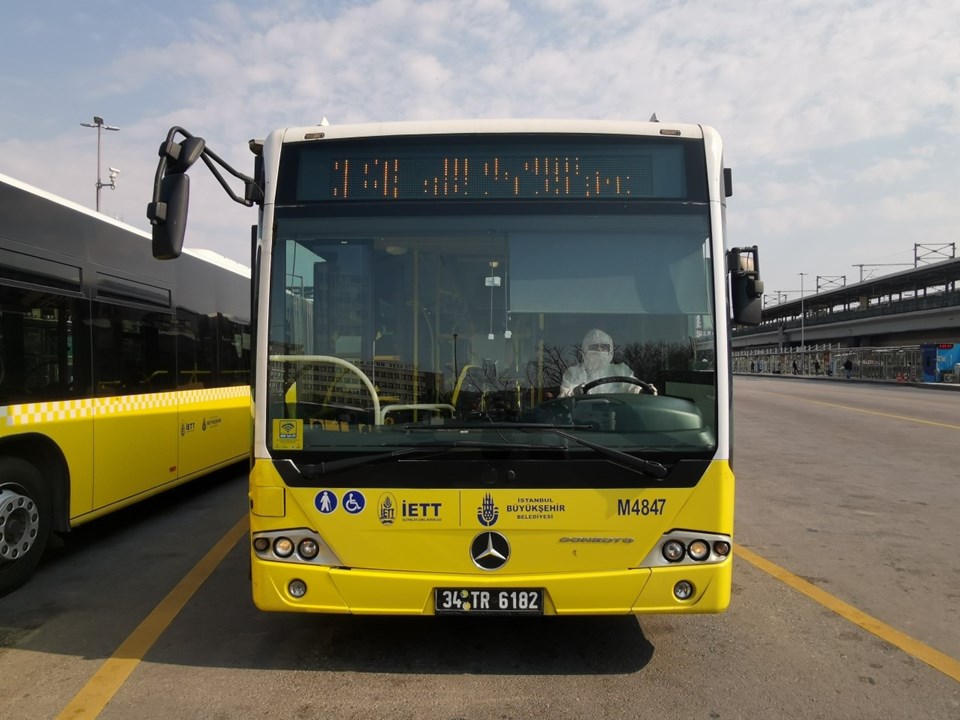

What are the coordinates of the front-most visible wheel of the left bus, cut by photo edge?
(0, 457, 51, 596)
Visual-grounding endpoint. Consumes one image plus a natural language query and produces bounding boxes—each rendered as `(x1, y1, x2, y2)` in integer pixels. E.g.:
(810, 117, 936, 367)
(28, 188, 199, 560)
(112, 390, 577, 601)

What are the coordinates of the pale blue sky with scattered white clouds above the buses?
(0, 0, 960, 303)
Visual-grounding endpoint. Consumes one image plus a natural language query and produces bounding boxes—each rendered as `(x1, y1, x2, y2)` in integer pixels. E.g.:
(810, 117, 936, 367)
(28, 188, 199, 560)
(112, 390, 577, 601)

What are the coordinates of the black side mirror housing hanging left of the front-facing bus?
(147, 134, 206, 260)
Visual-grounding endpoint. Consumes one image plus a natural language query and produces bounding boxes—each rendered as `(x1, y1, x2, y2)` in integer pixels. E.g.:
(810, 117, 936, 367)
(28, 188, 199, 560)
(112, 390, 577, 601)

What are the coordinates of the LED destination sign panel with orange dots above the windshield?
(278, 136, 706, 204)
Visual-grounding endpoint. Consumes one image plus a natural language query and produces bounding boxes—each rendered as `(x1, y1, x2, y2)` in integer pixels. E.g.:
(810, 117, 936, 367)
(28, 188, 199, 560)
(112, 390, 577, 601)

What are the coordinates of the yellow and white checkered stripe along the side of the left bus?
(0, 385, 250, 427)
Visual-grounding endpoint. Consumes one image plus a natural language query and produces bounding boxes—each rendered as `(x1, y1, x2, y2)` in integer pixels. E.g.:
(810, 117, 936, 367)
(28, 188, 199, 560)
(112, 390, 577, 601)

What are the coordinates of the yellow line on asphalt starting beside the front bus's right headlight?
(734, 545, 960, 682)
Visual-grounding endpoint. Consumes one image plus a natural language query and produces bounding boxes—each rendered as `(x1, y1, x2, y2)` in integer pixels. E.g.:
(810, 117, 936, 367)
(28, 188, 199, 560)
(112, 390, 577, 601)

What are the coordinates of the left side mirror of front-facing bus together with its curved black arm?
(147, 126, 263, 260)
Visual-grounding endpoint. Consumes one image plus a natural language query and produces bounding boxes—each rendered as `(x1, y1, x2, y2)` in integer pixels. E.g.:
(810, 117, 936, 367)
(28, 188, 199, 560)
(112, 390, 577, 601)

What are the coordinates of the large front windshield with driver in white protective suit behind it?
(268, 208, 717, 453)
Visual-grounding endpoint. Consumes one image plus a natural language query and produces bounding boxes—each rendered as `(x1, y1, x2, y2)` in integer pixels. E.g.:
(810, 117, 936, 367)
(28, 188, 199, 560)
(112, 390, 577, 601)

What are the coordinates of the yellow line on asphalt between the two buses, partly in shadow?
(57, 515, 248, 720)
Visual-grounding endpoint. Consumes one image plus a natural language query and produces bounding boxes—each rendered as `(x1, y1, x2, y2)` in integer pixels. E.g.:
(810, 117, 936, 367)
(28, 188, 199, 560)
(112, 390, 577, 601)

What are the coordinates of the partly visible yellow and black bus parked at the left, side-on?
(0, 175, 252, 594)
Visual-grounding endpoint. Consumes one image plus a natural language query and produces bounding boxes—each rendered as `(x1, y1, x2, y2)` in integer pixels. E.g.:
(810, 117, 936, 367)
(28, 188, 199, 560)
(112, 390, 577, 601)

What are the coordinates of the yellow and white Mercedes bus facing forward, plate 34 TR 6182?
(147, 120, 762, 615)
